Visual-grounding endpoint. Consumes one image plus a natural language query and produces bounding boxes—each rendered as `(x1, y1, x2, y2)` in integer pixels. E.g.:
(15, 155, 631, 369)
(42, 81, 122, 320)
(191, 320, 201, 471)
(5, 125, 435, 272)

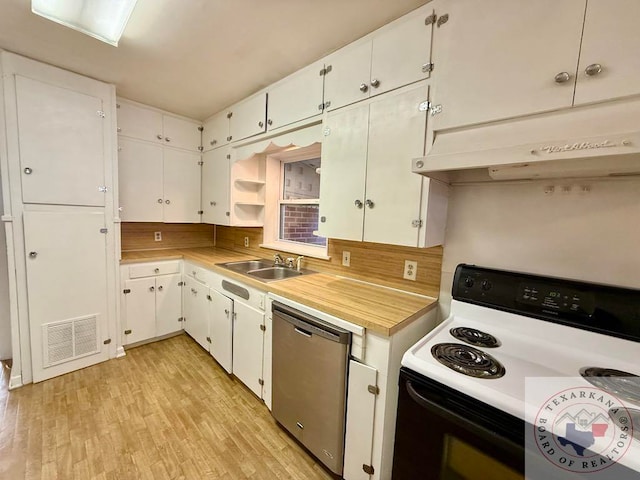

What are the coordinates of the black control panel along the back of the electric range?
(452, 264, 640, 341)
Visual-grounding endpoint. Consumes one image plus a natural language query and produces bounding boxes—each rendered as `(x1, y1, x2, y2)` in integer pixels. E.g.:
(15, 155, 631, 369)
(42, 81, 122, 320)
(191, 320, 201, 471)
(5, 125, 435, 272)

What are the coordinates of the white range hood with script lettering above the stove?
(412, 97, 640, 183)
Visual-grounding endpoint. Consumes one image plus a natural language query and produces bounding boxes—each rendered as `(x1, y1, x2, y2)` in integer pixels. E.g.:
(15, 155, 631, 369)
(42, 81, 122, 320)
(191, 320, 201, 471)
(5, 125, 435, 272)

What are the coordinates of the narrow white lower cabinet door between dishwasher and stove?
(343, 360, 382, 480)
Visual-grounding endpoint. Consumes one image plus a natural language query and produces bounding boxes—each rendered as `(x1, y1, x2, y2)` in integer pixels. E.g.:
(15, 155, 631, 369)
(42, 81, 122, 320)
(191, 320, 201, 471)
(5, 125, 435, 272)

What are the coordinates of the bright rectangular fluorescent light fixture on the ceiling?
(31, 0, 137, 47)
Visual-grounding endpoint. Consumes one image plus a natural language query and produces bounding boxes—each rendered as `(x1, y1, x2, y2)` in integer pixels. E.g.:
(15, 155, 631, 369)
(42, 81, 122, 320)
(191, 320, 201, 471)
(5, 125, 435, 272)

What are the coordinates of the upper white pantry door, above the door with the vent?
(16, 75, 109, 206)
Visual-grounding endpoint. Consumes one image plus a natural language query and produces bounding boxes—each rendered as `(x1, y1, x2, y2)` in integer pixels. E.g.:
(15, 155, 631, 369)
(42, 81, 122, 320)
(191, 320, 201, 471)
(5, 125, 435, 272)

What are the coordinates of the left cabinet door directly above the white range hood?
(432, 0, 585, 130)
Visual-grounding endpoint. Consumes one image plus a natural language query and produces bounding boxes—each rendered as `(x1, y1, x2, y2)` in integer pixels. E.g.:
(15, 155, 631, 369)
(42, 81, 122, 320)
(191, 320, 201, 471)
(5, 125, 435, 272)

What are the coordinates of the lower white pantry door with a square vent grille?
(23, 208, 109, 382)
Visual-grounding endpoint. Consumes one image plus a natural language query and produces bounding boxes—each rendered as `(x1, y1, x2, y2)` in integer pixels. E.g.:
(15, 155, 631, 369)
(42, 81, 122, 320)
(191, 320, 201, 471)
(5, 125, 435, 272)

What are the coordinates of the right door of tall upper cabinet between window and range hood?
(362, 86, 428, 247)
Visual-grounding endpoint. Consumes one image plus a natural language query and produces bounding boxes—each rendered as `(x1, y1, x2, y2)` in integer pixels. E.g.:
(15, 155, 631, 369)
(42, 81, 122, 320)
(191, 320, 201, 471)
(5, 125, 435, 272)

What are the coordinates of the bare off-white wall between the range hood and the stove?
(440, 177, 640, 318)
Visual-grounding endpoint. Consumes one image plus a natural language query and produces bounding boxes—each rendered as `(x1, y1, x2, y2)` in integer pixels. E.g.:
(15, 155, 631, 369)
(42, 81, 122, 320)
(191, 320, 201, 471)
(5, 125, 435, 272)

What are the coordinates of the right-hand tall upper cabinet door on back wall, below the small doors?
(163, 148, 201, 223)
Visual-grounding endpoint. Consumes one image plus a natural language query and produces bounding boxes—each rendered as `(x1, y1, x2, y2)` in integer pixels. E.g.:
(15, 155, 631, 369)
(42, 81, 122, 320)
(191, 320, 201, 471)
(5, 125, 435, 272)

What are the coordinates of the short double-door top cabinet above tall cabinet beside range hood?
(324, 5, 433, 110)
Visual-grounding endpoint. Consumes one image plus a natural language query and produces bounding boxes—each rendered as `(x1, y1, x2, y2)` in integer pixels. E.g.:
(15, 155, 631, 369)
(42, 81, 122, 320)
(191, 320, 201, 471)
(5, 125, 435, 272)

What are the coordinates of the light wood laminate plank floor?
(0, 335, 331, 480)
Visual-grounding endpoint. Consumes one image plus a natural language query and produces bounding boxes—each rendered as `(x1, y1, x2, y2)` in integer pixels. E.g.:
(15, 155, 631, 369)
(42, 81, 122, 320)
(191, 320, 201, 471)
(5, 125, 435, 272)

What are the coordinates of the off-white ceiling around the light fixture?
(0, 0, 428, 120)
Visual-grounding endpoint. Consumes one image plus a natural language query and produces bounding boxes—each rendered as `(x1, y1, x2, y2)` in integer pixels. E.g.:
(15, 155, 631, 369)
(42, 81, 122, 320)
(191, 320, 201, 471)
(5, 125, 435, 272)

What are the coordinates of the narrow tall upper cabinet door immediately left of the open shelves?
(202, 148, 230, 225)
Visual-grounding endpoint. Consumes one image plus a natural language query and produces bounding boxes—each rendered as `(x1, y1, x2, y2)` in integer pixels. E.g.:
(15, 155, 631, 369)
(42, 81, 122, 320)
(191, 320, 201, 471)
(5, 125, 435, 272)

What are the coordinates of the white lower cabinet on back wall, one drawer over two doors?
(120, 261, 182, 345)
